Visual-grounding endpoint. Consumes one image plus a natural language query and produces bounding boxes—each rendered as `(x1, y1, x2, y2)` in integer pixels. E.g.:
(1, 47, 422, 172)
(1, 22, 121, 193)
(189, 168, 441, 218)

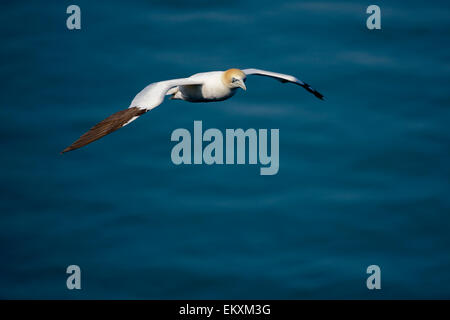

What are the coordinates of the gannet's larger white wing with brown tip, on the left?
(61, 78, 202, 153)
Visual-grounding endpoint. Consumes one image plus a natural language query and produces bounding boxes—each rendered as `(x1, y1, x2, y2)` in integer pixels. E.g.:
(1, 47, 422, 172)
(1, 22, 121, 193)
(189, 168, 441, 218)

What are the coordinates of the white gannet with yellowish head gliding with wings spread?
(61, 69, 323, 153)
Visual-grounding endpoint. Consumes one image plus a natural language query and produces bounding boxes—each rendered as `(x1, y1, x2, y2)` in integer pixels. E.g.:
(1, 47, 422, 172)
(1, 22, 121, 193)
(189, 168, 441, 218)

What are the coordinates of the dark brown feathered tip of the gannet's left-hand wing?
(61, 107, 147, 153)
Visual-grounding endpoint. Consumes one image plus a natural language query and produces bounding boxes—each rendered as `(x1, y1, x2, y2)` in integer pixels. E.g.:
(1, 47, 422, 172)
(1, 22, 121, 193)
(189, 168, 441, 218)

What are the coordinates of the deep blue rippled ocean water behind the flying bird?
(0, 0, 450, 299)
